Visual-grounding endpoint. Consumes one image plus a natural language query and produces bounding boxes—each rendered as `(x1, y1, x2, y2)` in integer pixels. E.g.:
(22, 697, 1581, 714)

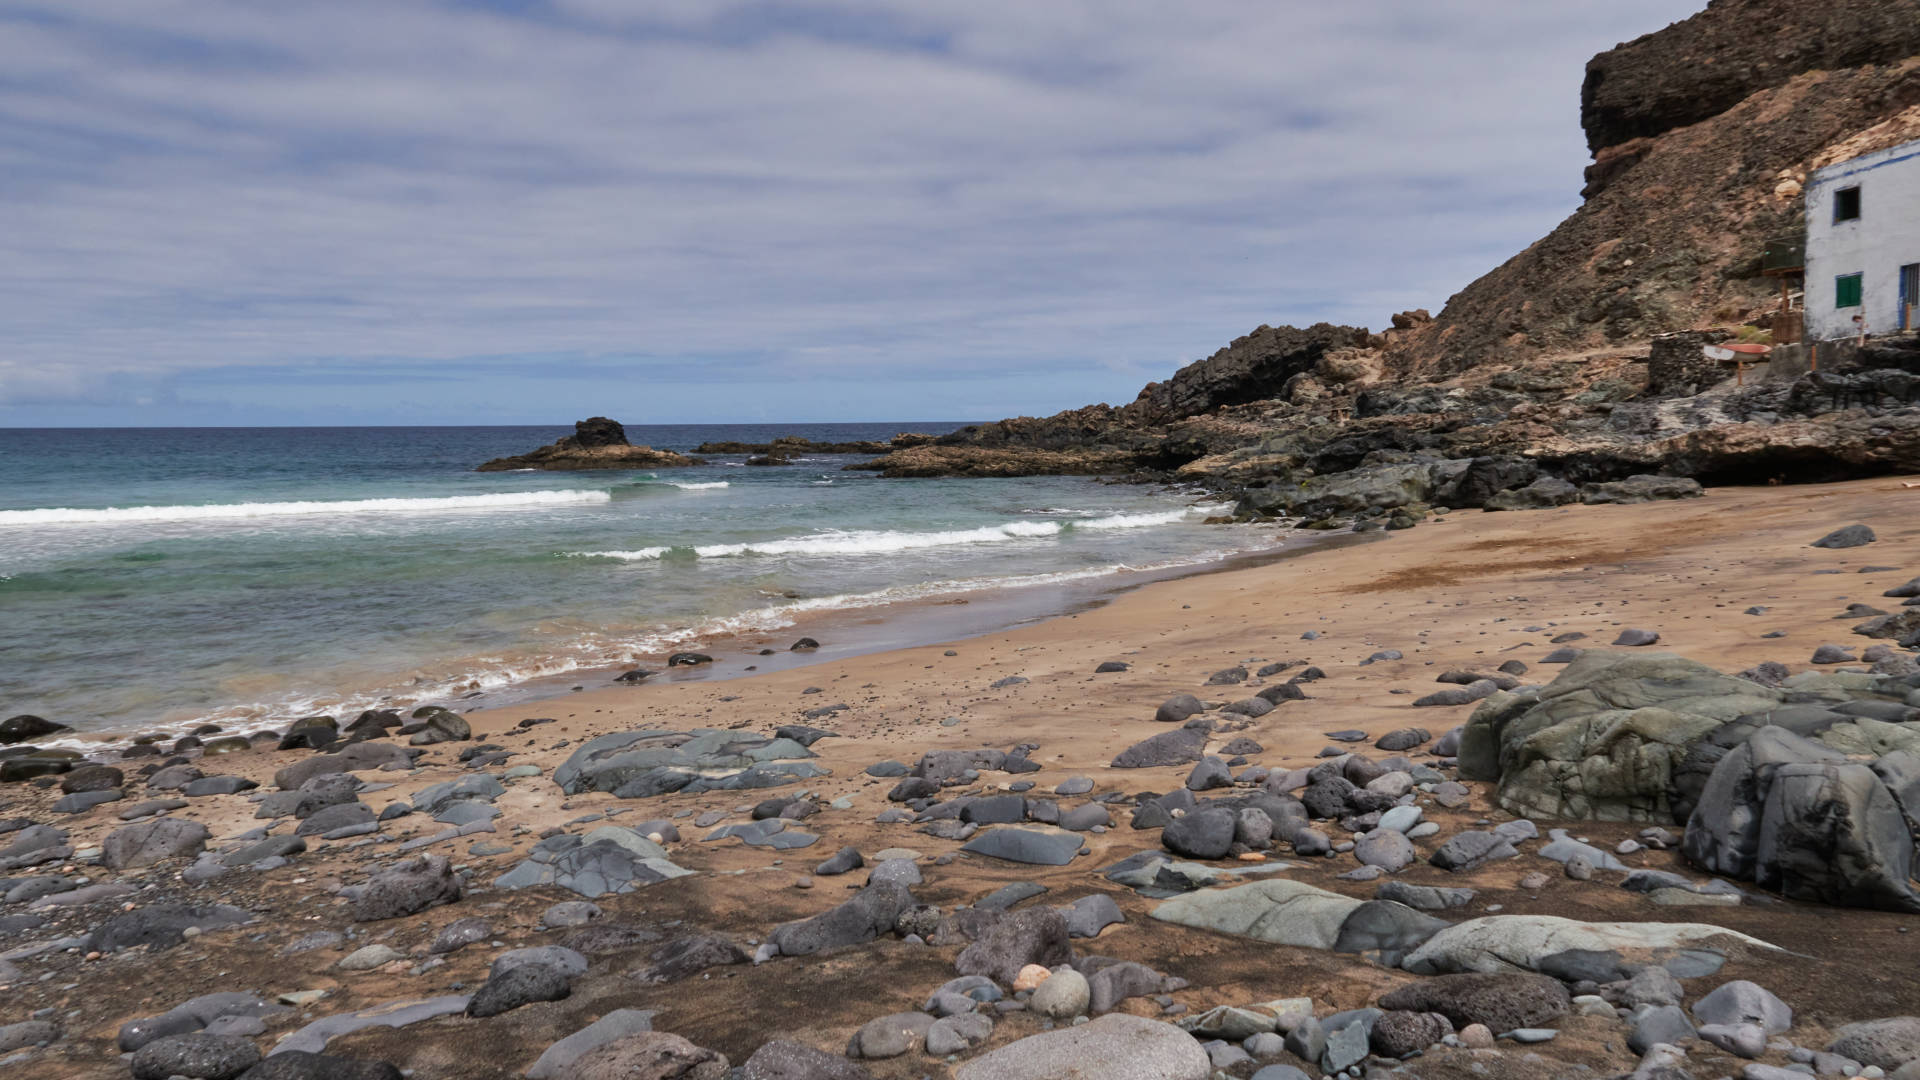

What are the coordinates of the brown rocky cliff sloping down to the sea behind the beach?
(852, 0, 1920, 519)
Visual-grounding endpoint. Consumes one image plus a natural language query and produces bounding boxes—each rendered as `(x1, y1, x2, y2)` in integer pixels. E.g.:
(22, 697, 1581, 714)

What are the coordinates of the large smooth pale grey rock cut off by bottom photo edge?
(954, 1013, 1213, 1080)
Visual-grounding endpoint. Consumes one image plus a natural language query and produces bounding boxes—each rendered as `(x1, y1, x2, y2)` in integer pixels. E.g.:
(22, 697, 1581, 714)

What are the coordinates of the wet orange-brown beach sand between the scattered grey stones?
(11, 479, 1920, 1080)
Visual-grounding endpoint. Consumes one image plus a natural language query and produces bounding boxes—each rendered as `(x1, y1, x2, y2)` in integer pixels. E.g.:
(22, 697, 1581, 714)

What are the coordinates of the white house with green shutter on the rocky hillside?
(1807, 142, 1920, 342)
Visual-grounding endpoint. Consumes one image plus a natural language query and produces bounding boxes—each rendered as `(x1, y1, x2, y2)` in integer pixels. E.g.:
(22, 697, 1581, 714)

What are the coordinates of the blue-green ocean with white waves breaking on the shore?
(0, 421, 1281, 732)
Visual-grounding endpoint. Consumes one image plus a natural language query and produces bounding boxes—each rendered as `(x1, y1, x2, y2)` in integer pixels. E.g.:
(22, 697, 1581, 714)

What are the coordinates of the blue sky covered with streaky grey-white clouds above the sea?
(0, 0, 1703, 427)
